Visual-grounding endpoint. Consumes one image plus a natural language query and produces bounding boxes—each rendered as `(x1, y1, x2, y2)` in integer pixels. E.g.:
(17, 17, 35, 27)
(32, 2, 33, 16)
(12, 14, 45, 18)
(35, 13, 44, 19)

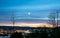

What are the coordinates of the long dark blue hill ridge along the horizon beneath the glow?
(0, 26, 60, 30)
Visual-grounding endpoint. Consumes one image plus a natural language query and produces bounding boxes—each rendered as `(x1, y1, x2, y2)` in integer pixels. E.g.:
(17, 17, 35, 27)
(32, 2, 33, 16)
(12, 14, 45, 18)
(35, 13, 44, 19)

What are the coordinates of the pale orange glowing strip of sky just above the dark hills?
(0, 23, 54, 27)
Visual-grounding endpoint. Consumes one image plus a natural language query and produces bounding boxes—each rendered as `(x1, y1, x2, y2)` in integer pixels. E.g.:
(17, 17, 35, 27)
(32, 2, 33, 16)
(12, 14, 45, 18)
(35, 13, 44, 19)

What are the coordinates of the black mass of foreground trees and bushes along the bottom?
(0, 27, 60, 38)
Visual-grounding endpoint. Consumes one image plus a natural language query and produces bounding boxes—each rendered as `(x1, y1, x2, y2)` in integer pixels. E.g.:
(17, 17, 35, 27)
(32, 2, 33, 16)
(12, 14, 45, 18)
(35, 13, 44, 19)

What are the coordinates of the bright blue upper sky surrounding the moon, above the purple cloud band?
(0, 0, 60, 20)
